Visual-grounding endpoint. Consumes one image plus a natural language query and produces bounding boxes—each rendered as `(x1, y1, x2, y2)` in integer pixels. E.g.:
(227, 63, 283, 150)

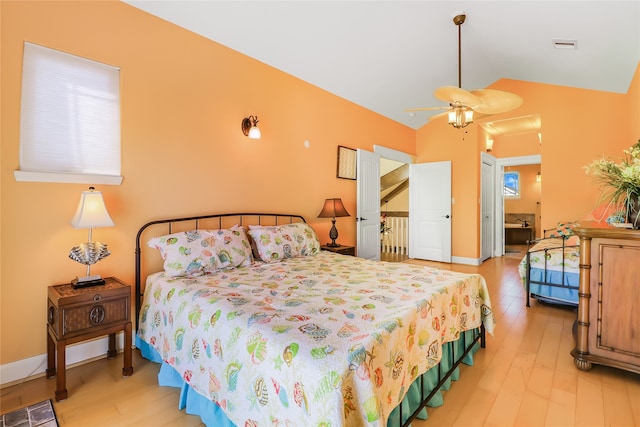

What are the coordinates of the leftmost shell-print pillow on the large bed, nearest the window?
(147, 230, 219, 276)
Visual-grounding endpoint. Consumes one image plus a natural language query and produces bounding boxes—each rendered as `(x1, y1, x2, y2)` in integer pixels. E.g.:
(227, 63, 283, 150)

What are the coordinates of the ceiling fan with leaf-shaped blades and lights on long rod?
(405, 14, 523, 129)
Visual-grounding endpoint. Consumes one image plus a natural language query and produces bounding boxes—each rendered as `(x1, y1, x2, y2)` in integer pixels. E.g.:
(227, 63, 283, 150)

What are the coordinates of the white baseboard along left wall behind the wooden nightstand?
(0, 333, 125, 388)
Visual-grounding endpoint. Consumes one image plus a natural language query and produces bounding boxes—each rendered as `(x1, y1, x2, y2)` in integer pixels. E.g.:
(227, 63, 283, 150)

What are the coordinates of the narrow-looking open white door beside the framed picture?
(356, 149, 380, 261)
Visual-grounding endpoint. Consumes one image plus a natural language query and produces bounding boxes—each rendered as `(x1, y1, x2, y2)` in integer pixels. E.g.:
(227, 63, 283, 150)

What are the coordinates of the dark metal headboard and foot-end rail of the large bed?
(135, 213, 486, 427)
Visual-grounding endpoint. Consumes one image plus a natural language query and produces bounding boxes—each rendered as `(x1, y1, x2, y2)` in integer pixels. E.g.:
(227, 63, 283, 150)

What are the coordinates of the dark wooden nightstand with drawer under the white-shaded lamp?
(47, 277, 133, 400)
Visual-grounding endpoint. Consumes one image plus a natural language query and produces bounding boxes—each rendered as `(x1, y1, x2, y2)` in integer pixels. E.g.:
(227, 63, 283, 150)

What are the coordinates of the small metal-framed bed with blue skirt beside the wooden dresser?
(518, 223, 580, 307)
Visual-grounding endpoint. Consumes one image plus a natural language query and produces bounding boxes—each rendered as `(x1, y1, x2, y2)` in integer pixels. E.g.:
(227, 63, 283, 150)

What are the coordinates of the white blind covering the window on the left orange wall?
(15, 43, 122, 184)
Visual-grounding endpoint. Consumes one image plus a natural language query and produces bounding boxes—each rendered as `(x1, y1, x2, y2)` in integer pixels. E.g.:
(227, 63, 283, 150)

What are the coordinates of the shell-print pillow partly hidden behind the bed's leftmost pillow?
(205, 225, 253, 272)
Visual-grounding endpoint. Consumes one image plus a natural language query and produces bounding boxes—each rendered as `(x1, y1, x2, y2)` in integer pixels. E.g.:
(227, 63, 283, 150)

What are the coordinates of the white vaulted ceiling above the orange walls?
(123, 0, 640, 129)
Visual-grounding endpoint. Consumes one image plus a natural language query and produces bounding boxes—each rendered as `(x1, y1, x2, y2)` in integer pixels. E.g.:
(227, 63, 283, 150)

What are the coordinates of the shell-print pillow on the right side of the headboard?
(249, 223, 320, 262)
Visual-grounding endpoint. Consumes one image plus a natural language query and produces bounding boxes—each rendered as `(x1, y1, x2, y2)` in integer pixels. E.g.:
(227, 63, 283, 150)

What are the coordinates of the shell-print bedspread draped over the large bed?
(138, 251, 494, 427)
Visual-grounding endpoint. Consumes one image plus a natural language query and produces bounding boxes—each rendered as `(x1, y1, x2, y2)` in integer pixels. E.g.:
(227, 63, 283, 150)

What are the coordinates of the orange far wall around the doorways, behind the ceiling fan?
(416, 67, 640, 258)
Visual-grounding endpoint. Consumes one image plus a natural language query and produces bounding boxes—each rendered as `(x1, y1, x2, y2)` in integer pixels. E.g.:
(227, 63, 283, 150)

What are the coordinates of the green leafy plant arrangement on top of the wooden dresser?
(585, 141, 640, 228)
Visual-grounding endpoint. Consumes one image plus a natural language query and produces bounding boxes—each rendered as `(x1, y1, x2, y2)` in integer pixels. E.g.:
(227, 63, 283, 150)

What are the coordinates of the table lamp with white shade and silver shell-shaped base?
(69, 187, 113, 288)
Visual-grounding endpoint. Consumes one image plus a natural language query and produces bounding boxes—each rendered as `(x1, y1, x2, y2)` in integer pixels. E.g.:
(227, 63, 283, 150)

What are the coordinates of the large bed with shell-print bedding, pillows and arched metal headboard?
(135, 214, 494, 427)
